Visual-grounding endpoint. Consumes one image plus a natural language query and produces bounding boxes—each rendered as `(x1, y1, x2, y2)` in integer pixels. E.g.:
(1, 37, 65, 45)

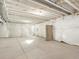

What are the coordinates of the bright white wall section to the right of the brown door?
(54, 15, 79, 45)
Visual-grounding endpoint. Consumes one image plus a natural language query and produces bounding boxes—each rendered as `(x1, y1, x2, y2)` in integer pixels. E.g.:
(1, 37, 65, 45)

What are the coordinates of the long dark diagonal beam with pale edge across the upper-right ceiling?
(33, 0, 71, 15)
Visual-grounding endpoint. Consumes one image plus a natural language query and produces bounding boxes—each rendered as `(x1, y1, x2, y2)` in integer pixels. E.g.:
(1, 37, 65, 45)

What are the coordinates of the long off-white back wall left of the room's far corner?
(0, 23, 32, 37)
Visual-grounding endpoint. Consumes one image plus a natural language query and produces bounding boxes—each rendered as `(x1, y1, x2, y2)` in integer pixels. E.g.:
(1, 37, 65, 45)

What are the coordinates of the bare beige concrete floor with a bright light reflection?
(0, 37, 79, 59)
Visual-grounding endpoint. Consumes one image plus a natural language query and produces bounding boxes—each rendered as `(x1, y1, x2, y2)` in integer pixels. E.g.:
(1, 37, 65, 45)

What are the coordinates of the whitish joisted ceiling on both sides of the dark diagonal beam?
(5, 0, 79, 23)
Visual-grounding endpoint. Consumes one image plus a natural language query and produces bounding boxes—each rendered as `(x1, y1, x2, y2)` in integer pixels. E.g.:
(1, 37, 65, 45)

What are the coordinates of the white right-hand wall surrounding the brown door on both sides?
(35, 15, 79, 45)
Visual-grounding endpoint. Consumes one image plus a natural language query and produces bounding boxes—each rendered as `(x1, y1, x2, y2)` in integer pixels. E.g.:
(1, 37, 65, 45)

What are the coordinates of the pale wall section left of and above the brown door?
(34, 21, 53, 37)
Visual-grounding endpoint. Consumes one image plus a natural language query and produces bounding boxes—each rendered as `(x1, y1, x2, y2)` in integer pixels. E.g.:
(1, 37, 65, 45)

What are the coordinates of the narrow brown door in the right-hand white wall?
(46, 25, 53, 41)
